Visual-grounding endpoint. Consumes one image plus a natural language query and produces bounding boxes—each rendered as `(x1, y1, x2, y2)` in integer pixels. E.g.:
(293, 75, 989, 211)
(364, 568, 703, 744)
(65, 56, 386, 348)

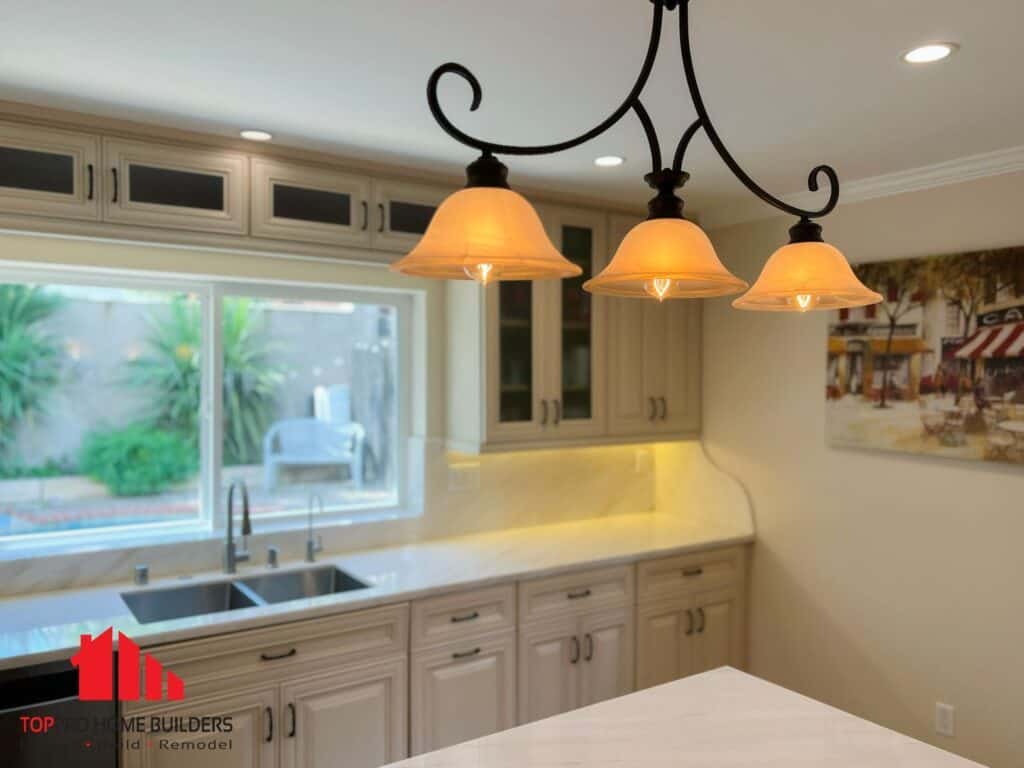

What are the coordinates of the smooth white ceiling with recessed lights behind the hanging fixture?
(0, 0, 1024, 219)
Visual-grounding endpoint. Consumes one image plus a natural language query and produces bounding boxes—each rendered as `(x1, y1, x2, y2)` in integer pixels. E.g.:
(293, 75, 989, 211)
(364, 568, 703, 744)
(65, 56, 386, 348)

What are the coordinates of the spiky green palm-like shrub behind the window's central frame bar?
(128, 298, 284, 465)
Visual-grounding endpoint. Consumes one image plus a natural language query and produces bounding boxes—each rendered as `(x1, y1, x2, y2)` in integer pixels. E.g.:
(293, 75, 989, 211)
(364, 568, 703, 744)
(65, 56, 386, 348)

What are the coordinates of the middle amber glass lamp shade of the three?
(583, 217, 748, 301)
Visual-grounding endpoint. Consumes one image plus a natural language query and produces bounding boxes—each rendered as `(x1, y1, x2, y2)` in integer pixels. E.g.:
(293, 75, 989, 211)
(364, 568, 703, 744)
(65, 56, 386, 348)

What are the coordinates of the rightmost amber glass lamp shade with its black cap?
(732, 222, 882, 312)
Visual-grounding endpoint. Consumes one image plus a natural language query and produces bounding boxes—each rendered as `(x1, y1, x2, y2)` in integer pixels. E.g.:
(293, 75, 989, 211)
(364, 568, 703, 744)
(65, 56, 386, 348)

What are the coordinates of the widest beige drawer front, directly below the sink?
(139, 604, 409, 695)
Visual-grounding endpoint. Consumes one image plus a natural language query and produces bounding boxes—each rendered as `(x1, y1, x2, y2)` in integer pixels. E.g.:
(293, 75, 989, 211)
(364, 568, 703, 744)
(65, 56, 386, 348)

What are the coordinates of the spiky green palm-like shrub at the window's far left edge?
(0, 285, 63, 456)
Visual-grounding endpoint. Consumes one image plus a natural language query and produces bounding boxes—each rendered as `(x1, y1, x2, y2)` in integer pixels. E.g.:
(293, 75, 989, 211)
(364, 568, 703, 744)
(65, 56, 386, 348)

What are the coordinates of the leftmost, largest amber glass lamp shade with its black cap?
(391, 158, 583, 285)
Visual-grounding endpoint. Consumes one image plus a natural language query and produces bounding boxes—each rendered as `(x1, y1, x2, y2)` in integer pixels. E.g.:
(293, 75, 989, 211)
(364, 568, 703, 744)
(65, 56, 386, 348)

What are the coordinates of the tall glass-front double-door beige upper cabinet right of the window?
(447, 207, 607, 452)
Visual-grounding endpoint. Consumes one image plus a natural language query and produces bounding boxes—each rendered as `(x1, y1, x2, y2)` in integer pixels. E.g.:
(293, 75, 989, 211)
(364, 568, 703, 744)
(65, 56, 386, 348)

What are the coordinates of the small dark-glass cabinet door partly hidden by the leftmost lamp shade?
(371, 179, 455, 254)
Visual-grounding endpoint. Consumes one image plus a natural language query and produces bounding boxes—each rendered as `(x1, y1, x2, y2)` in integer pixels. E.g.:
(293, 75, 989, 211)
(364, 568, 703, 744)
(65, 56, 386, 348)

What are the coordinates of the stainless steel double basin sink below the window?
(121, 565, 369, 624)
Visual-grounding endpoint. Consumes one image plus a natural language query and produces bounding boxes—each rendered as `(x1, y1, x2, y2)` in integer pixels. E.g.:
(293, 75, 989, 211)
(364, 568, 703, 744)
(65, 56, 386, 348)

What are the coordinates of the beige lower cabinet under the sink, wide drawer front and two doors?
(122, 605, 409, 768)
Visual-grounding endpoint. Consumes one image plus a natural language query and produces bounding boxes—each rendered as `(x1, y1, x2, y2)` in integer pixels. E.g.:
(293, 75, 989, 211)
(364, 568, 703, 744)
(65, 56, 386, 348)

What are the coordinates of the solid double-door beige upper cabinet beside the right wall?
(607, 216, 701, 439)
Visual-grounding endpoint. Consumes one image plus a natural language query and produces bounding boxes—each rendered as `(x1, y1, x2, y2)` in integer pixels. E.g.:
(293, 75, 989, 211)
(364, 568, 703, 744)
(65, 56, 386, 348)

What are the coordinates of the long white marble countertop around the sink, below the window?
(0, 514, 754, 669)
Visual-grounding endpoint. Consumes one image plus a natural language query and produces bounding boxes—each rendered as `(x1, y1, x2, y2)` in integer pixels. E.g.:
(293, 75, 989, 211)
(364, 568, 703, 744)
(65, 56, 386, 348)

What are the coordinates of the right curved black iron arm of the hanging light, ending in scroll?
(675, 0, 839, 219)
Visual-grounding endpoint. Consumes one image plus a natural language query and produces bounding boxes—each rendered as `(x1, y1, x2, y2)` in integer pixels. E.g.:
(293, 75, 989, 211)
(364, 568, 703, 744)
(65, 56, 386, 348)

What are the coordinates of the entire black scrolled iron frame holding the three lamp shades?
(427, 0, 839, 219)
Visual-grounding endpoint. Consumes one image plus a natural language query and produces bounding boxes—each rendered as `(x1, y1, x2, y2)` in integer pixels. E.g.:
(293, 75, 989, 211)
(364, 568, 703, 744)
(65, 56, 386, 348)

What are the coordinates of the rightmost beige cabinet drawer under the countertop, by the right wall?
(637, 547, 743, 602)
